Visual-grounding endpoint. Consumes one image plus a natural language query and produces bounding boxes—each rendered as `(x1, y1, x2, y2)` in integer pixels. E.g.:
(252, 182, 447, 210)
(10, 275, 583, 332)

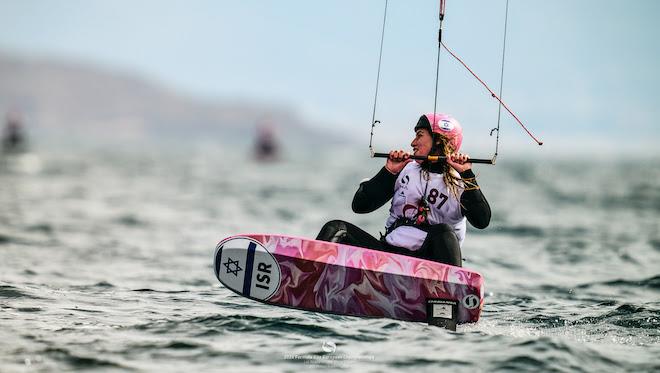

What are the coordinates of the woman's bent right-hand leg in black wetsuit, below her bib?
(419, 224, 463, 267)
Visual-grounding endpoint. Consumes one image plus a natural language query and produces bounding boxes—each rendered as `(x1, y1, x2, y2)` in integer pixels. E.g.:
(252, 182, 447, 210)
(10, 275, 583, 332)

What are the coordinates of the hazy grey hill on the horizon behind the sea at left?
(0, 54, 340, 142)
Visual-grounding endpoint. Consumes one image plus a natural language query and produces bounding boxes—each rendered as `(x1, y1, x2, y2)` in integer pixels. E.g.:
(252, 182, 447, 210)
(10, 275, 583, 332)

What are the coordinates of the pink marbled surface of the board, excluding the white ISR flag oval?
(219, 234, 483, 323)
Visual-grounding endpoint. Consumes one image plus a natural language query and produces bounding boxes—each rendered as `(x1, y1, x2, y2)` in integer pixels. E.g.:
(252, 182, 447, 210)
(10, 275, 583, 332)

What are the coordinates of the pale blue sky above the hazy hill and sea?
(0, 0, 660, 153)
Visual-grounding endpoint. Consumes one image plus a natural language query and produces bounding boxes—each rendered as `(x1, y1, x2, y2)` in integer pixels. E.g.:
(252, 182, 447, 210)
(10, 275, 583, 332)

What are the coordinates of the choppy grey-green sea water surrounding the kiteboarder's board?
(0, 142, 660, 372)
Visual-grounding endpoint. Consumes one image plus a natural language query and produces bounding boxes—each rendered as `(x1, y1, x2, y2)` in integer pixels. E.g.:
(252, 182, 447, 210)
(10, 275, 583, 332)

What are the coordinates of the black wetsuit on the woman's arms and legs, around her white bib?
(316, 167, 490, 266)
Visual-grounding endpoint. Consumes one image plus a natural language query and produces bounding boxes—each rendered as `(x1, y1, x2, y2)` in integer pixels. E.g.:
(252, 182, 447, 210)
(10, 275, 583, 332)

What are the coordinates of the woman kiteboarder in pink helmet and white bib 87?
(316, 114, 490, 266)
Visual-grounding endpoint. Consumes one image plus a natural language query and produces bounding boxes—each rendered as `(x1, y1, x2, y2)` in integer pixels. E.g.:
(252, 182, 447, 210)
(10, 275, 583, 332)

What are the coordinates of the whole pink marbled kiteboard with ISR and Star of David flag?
(214, 234, 484, 330)
